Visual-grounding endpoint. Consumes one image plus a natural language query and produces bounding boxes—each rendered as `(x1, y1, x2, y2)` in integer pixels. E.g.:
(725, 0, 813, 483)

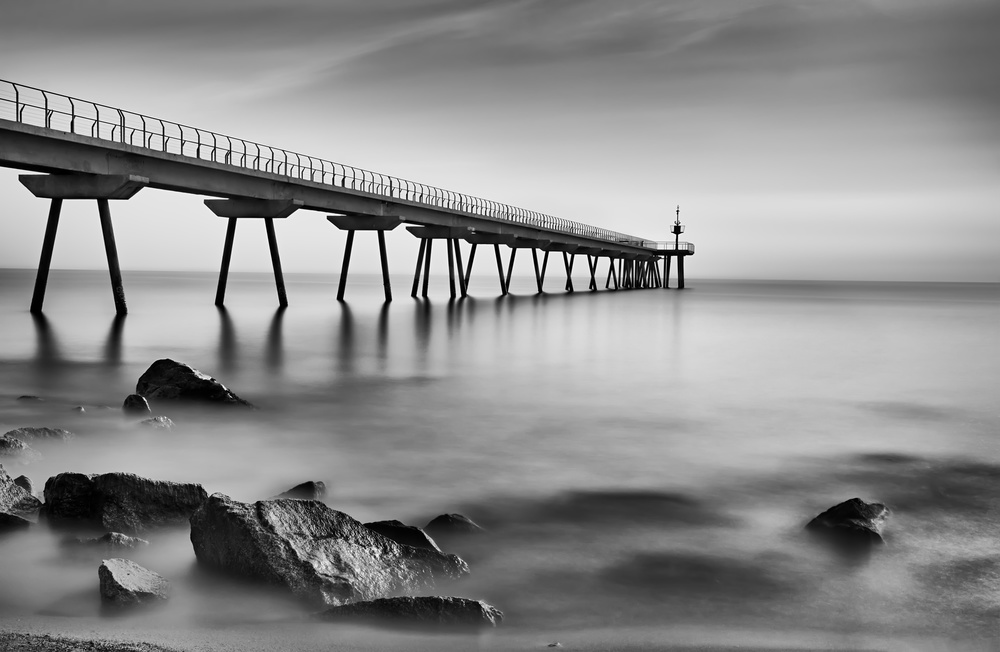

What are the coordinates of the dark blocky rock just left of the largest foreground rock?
(45, 473, 208, 532)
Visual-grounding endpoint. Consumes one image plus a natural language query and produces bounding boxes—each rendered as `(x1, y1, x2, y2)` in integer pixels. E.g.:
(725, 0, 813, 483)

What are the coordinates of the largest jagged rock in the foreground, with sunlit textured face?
(191, 494, 469, 605)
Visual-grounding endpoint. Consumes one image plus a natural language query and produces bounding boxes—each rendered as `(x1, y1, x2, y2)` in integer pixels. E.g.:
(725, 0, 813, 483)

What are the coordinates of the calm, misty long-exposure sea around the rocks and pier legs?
(0, 270, 1000, 650)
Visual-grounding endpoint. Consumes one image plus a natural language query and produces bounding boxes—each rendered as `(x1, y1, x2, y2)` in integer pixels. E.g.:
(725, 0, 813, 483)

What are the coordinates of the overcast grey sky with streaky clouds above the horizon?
(0, 0, 1000, 281)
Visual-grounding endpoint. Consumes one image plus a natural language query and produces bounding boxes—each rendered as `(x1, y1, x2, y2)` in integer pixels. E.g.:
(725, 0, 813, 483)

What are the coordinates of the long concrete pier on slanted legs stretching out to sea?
(0, 80, 694, 314)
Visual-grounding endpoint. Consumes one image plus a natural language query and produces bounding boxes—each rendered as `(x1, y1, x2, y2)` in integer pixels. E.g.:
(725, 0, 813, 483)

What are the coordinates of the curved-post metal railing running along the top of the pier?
(0, 79, 672, 251)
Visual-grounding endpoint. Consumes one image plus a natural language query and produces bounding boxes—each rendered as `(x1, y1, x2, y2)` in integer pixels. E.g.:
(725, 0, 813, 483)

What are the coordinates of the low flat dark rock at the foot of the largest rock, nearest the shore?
(317, 596, 503, 629)
